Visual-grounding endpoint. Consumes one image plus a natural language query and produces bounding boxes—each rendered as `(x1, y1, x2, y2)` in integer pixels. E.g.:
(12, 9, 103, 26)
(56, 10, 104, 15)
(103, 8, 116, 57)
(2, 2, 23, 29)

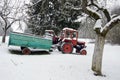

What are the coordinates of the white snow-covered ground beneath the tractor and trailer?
(0, 38, 120, 80)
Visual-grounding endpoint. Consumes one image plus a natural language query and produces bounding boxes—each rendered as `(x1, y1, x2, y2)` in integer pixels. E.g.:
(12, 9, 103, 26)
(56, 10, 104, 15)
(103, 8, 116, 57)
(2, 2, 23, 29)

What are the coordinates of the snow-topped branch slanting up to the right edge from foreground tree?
(101, 16, 120, 33)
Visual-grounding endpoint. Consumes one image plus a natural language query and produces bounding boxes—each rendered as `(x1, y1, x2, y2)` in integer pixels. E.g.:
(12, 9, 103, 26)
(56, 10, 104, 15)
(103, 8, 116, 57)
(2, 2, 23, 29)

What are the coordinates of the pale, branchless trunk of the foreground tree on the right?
(92, 34, 105, 75)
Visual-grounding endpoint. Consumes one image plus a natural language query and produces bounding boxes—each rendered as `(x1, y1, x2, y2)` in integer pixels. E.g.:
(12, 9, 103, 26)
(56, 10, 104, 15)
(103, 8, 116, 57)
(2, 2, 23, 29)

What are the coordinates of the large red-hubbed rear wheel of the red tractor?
(61, 43, 73, 53)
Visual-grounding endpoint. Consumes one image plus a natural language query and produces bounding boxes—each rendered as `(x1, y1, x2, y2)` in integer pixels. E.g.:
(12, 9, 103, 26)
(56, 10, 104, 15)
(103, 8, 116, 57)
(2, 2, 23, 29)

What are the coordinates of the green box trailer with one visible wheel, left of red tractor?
(8, 32, 52, 54)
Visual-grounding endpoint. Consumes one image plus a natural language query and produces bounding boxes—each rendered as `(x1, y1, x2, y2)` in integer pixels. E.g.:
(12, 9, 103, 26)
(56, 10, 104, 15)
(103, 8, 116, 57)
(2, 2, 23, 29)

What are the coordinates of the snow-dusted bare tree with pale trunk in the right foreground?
(82, 0, 120, 75)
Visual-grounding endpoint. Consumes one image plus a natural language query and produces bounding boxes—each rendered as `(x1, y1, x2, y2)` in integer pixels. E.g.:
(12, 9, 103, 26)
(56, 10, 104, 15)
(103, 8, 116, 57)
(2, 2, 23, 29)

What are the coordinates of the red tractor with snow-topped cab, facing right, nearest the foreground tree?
(58, 28, 87, 55)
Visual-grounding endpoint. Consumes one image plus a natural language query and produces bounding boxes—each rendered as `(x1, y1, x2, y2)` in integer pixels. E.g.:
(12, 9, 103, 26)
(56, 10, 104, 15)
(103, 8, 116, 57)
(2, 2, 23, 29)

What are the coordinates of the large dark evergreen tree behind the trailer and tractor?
(28, 0, 81, 34)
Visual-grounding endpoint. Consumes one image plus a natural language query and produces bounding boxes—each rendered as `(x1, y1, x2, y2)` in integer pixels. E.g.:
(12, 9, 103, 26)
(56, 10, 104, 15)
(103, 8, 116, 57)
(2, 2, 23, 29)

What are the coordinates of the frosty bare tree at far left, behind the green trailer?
(0, 0, 26, 43)
